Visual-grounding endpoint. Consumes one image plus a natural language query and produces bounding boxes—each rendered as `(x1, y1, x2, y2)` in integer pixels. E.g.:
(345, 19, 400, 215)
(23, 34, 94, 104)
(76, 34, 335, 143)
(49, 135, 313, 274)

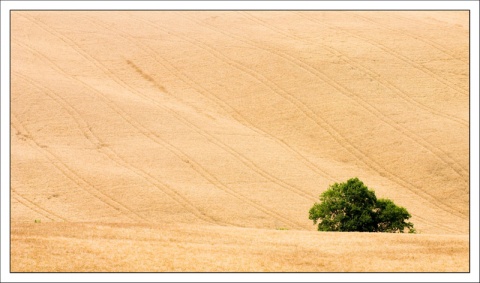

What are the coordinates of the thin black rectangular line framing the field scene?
(8, 10, 472, 274)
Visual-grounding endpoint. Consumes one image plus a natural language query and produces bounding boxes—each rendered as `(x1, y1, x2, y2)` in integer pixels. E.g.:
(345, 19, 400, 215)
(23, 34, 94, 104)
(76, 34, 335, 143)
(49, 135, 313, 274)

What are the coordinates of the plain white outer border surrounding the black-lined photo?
(0, 1, 480, 282)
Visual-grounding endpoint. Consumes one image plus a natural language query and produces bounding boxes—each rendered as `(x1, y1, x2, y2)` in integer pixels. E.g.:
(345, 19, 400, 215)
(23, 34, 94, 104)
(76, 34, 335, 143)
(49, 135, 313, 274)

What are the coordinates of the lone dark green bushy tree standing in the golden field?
(309, 178, 415, 233)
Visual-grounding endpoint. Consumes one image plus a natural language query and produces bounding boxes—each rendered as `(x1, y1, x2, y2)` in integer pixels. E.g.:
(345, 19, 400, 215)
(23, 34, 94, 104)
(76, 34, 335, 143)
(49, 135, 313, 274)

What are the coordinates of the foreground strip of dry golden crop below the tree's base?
(12, 223, 469, 272)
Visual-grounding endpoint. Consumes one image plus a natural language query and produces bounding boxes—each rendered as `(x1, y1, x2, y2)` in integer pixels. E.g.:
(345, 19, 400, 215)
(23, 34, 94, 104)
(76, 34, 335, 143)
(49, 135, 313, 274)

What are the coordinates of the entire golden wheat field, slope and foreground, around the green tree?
(10, 11, 470, 272)
